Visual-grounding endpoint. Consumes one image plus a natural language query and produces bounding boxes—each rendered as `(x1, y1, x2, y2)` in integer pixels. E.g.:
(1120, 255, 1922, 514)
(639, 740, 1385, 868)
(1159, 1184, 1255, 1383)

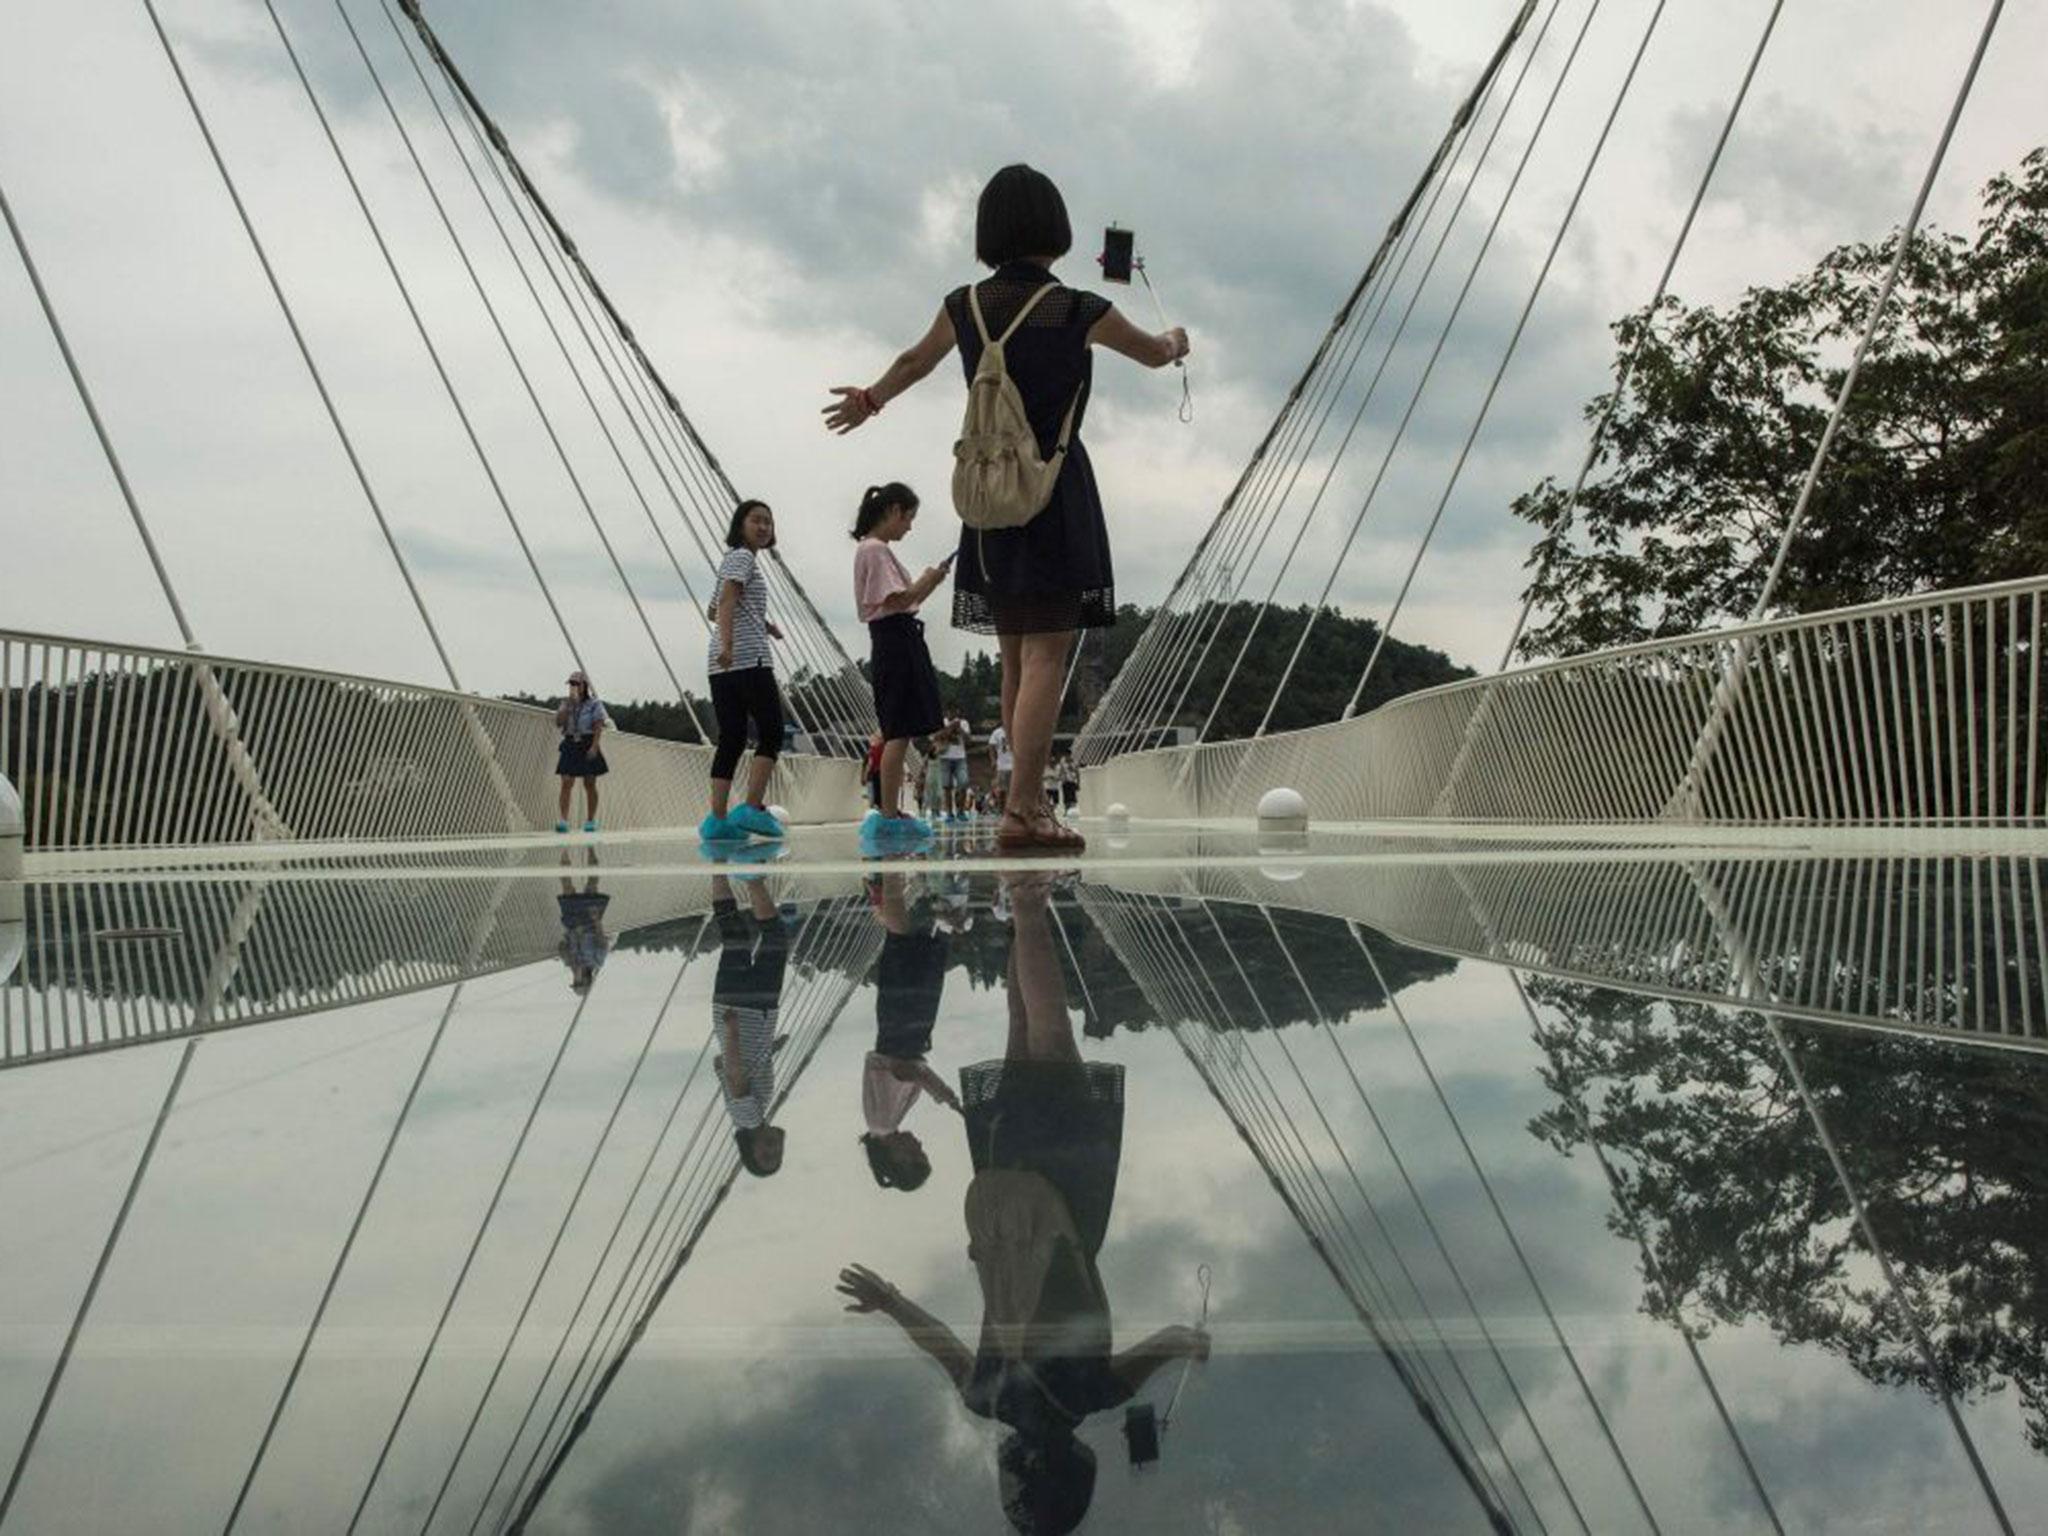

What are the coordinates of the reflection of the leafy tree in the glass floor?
(1530, 981, 2048, 1452)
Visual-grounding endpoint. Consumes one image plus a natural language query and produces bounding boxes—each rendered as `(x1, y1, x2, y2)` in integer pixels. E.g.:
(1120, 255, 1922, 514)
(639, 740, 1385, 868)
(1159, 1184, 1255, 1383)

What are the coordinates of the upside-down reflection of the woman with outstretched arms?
(838, 879, 1208, 1532)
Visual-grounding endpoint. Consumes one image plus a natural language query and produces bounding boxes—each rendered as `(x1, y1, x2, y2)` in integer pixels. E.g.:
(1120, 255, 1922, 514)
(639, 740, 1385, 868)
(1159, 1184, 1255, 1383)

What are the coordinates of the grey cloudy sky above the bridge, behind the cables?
(0, 0, 2048, 696)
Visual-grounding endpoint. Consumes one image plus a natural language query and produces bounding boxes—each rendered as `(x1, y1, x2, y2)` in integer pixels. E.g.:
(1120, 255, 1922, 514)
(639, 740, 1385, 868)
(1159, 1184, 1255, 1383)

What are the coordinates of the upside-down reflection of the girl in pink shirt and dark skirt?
(860, 874, 961, 1192)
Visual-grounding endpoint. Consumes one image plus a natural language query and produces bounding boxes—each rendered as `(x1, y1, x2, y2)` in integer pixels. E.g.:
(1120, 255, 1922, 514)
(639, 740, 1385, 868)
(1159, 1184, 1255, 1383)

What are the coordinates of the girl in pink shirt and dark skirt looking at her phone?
(854, 481, 952, 838)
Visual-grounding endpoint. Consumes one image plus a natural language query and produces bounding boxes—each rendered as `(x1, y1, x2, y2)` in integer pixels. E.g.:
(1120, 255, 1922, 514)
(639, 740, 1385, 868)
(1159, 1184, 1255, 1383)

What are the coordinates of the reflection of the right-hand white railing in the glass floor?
(1114, 852, 2048, 1051)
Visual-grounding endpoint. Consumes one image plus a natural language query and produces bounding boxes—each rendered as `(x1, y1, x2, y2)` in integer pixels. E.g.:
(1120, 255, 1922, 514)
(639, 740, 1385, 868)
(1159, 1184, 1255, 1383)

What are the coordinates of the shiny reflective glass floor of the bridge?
(0, 827, 2048, 1536)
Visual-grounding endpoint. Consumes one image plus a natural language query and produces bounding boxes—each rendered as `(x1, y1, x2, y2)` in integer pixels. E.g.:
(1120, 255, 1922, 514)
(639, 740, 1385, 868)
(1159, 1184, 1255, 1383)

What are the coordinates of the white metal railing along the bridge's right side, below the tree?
(1085, 578, 2048, 825)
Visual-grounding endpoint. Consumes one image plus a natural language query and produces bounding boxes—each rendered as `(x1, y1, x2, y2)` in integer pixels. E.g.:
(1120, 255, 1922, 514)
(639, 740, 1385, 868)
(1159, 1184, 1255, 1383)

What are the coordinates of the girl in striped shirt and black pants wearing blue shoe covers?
(698, 502, 782, 842)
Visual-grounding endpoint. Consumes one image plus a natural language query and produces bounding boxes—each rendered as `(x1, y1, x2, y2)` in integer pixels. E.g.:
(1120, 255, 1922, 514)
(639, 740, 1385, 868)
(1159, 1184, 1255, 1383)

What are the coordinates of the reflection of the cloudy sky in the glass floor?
(16, 897, 2048, 1536)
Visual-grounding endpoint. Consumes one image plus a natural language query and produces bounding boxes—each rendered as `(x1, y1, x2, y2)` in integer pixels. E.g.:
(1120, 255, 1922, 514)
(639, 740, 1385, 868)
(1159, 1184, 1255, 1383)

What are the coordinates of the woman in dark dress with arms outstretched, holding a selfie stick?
(825, 166, 1188, 868)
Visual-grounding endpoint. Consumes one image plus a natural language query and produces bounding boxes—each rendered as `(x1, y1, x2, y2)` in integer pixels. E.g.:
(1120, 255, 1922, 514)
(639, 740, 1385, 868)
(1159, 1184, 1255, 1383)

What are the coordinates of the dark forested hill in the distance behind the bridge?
(516, 602, 1473, 741)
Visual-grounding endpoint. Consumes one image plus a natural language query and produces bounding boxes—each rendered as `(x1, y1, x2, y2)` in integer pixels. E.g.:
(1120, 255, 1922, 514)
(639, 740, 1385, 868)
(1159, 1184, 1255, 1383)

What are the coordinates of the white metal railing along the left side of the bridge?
(0, 631, 860, 850)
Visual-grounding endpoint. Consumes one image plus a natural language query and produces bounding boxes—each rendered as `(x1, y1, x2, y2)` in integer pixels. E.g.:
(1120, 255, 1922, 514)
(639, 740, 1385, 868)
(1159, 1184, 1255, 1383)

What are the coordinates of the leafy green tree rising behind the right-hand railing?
(1513, 150, 2048, 655)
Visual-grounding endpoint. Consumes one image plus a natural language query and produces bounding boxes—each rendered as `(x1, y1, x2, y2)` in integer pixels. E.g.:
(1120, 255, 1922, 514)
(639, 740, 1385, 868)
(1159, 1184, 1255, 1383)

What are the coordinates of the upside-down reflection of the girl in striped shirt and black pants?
(711, 874, 788, 1178)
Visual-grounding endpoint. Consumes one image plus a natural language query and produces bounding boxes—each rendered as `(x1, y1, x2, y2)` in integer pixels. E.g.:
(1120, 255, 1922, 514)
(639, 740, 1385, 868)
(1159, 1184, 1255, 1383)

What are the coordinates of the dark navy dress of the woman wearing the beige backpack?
(946, 262, 1116, 635)
